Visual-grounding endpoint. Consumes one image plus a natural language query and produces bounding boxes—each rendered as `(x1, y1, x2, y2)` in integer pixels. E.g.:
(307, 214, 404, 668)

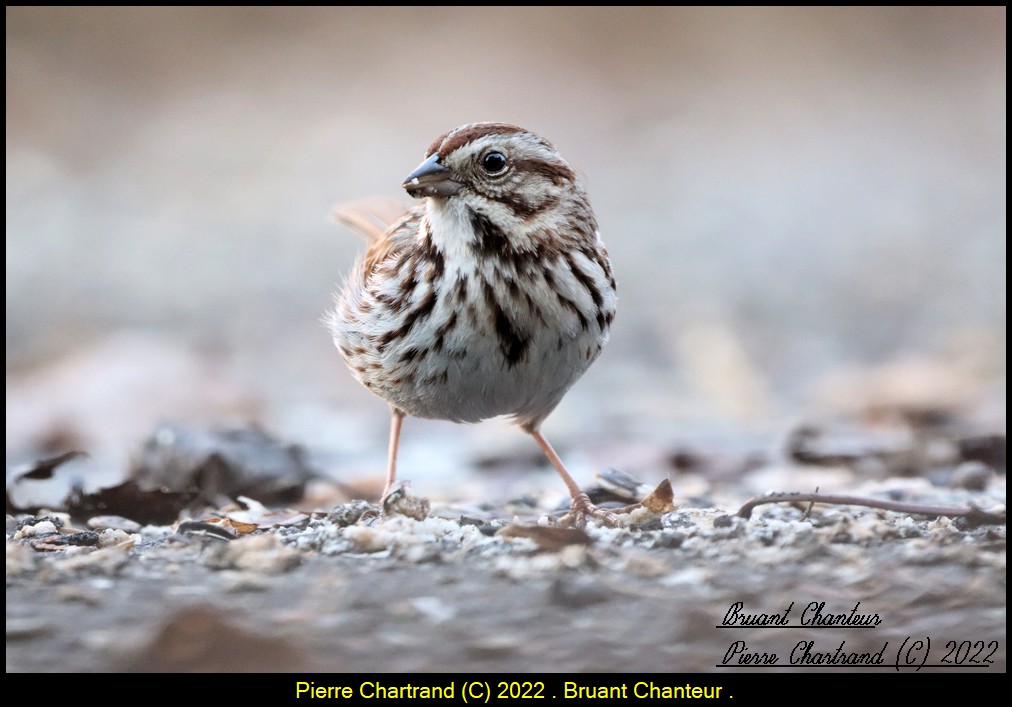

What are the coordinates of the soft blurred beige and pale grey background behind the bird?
(6, 8, 1006, 496)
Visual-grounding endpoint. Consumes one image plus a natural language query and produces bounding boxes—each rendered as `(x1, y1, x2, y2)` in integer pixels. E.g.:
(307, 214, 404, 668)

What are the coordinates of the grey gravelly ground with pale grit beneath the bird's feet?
(6, 467, 1006, 674)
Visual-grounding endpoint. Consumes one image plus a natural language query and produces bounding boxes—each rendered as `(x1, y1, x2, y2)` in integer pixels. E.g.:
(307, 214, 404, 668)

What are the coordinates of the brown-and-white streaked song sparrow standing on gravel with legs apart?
(329, 122, 615, 521)
